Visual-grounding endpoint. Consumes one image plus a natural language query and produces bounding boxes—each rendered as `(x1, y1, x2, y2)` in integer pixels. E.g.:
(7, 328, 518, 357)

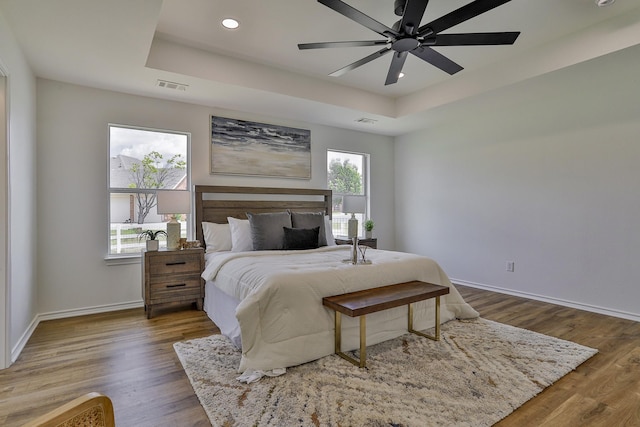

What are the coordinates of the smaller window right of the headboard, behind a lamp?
(327, 150, 369, 237)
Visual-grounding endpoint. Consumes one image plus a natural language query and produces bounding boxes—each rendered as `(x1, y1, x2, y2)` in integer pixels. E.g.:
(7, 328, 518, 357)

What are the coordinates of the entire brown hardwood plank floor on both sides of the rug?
(0, 286, 640, 427)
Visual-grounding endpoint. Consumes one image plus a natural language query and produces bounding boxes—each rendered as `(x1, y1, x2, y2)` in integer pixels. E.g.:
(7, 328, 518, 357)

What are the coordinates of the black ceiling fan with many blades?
(298, 0, 520, 85)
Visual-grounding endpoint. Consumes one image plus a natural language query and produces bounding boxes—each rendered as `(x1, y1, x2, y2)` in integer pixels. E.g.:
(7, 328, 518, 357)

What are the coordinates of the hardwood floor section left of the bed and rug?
(0, 308, 219, 427)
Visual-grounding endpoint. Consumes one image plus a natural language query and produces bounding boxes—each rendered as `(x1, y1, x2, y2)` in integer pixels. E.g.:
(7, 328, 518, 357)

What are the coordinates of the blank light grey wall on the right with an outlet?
(395, 47, 640, 320)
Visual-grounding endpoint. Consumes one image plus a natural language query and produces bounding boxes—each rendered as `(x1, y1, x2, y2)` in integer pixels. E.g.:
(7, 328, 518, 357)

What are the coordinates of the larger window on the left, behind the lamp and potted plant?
(108, 125, 191, 257)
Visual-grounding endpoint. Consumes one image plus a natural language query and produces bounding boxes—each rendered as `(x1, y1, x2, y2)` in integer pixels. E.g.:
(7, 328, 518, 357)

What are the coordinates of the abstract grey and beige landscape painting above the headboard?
(211, 116, 311, 179)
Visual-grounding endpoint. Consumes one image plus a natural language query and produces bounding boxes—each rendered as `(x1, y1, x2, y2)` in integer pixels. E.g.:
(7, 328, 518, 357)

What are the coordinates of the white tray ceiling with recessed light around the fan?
(0, 0, 640, 135)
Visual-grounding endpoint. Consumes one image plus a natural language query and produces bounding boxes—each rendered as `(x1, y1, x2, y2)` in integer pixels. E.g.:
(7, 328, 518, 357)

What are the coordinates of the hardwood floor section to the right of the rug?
(456, 286, 640, 427)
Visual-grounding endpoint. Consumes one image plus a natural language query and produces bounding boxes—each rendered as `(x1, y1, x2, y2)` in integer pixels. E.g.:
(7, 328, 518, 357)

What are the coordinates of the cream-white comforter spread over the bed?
(202, 246, 478, 372)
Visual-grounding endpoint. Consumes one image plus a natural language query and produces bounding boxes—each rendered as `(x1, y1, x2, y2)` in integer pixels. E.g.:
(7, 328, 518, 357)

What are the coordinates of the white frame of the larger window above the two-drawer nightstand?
(105, 123, 193, 265)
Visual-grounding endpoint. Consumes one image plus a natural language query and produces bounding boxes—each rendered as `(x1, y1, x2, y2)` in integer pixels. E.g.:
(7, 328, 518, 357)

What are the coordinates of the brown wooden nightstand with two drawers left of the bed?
(142, 248, 204, 319)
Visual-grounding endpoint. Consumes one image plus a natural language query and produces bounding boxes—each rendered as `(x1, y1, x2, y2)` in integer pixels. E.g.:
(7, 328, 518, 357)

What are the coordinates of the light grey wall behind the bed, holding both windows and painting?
(37, 79, 394, 314)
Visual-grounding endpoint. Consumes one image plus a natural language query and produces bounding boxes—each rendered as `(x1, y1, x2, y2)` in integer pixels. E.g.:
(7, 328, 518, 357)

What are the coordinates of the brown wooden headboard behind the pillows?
(195, 185, 332, 247)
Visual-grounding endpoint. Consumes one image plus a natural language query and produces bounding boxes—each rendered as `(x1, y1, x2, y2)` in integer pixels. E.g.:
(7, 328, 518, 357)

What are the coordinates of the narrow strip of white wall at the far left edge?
(0, 8, 37, 368)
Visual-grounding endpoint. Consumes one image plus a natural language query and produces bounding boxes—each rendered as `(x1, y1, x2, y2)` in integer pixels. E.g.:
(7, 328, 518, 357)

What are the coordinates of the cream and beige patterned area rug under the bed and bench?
(174, 319, 597, 427)
